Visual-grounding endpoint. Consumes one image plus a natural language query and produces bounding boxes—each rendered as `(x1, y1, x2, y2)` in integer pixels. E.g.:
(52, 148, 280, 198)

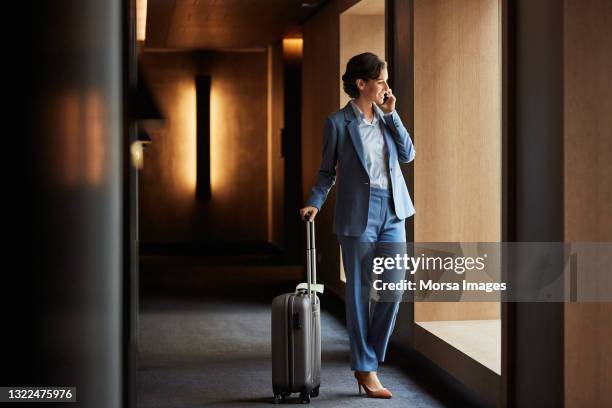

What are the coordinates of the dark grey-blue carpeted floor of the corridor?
(137, 284, 476, 408)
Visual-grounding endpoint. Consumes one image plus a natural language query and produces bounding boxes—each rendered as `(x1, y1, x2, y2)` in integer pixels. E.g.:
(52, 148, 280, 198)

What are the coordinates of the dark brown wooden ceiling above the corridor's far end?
(145, 0, 325, 50)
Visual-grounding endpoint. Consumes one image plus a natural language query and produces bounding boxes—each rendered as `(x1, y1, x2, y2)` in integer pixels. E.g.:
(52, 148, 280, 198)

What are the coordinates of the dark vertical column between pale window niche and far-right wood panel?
(508, 0, 564, 407)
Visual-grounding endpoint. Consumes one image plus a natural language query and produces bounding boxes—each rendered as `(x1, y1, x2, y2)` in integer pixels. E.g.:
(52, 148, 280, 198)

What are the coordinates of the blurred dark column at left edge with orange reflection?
(0, 0, 125, 408)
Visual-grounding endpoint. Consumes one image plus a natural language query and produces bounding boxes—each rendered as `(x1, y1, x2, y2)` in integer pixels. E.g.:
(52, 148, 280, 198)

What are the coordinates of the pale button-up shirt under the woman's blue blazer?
(351, 100, 393, 190)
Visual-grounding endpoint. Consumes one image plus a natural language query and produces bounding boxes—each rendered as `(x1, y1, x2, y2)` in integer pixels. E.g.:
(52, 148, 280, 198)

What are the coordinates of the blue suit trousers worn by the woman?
(338, 188, 406, 371)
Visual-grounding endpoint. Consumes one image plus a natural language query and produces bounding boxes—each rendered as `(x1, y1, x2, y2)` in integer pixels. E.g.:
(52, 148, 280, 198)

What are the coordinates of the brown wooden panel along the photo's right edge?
(564, 0, 612, 407)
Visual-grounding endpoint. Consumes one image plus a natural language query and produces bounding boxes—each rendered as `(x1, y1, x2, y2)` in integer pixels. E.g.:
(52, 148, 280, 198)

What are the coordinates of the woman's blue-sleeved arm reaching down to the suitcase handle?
(300, 117, 338, 219)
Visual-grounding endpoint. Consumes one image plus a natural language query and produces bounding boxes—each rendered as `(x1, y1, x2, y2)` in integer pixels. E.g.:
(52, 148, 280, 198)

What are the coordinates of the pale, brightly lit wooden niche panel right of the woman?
(414, 0, 501, 321)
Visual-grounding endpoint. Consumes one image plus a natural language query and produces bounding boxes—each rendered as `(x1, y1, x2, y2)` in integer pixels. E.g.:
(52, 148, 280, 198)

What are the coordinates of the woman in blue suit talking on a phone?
(300, 52, 415, 398)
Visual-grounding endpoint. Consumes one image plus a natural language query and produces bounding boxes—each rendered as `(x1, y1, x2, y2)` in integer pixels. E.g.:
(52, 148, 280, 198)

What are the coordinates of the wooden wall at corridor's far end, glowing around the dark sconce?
(139, 52, 268, 243)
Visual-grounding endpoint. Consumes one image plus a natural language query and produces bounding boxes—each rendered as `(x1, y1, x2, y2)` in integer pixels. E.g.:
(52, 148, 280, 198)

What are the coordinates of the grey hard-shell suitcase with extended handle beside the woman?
(272, 221, 322, 404)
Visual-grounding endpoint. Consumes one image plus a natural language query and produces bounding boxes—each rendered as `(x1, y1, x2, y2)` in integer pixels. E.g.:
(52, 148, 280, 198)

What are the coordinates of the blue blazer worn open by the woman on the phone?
(306, 102, 415, 236)
